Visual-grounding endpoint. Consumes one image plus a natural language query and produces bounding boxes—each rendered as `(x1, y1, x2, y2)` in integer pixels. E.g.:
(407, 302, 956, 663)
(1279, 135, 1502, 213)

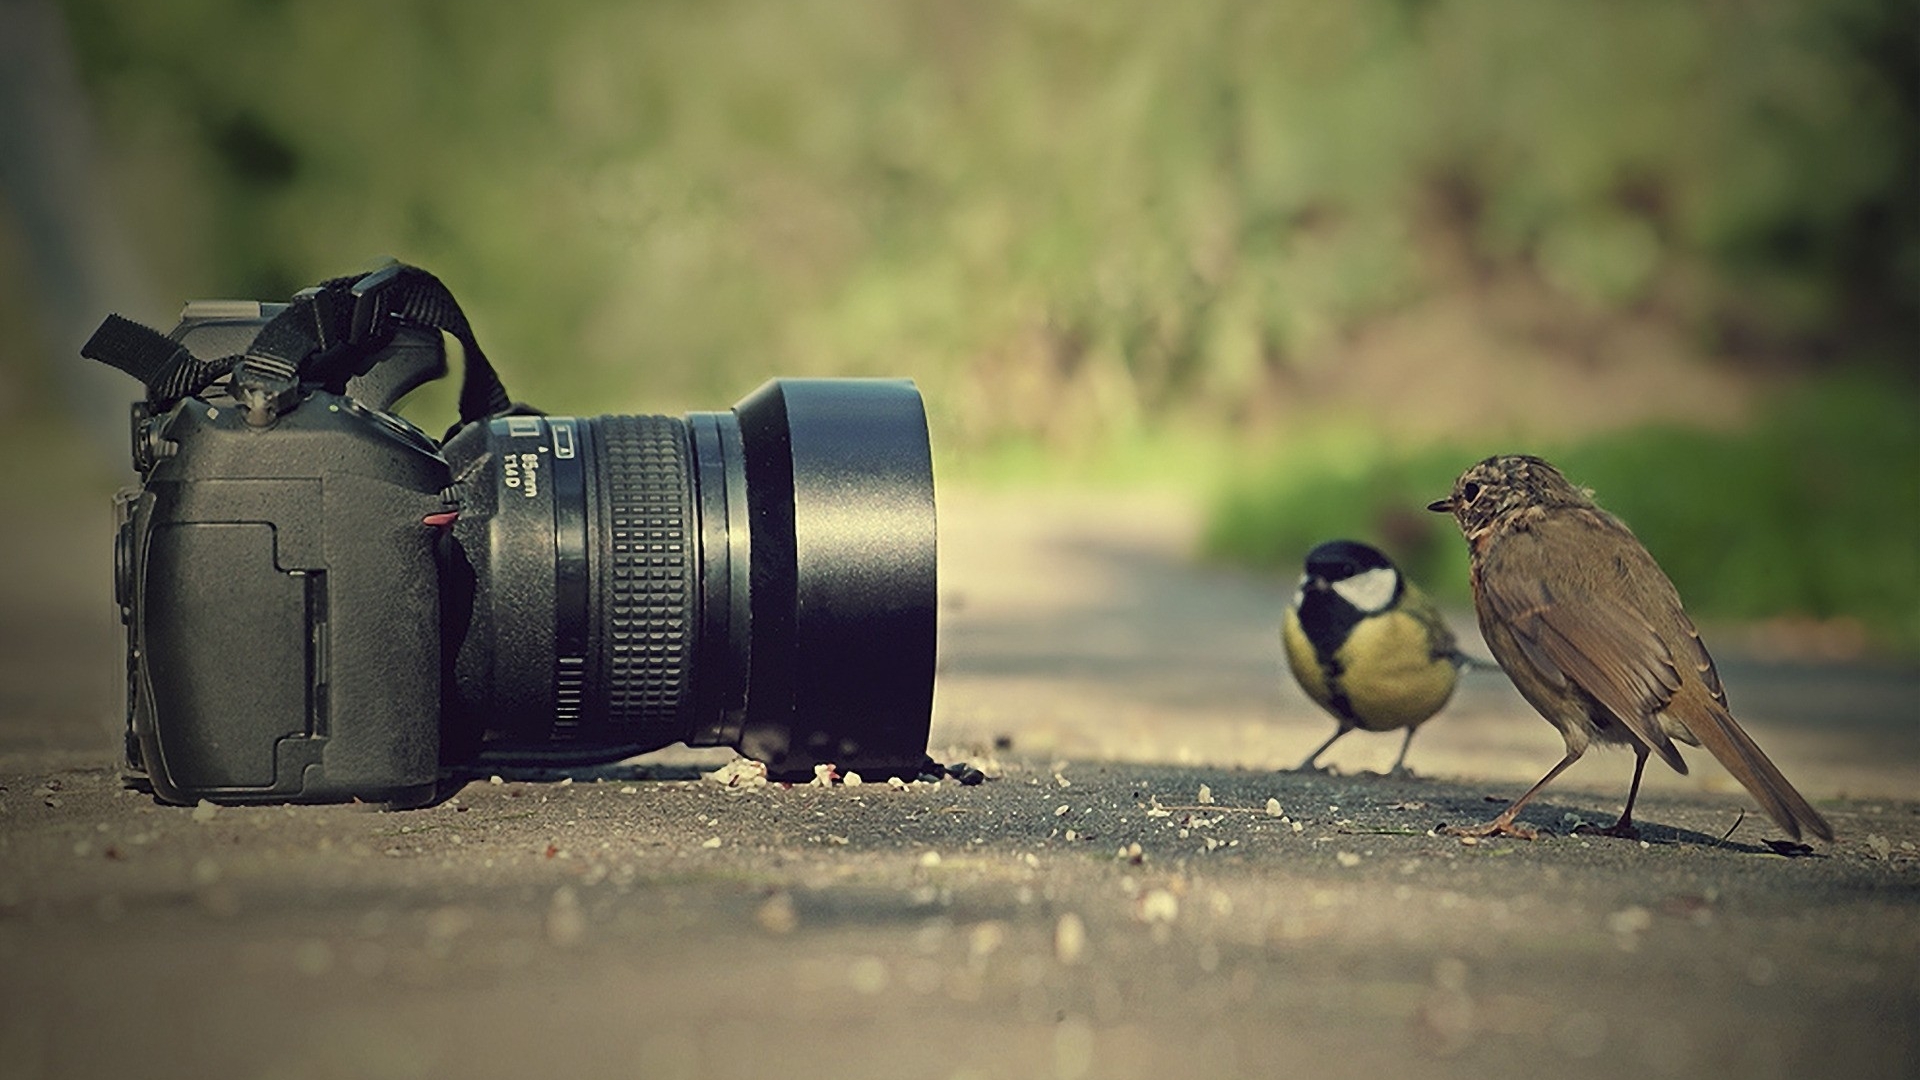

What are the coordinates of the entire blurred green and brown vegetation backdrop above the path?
(0, 0, 1920, 650)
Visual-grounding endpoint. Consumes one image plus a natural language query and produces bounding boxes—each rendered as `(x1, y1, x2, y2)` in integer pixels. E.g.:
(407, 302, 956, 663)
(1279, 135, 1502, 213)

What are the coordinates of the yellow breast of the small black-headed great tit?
(1336, 609, 1459, 730)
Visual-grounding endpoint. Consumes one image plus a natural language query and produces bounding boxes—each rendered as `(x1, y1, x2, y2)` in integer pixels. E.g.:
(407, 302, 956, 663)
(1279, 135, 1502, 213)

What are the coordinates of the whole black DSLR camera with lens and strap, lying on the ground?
(83, 265, 935, 805)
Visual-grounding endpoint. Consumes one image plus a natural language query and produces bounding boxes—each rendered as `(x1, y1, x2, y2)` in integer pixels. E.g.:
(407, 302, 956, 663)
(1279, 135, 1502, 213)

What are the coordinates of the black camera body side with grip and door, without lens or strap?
(125, 394, 447, 805)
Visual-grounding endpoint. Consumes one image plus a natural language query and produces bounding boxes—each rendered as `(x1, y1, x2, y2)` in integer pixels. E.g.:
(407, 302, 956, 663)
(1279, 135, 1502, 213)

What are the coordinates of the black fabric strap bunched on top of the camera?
(81, 263, 513, 427)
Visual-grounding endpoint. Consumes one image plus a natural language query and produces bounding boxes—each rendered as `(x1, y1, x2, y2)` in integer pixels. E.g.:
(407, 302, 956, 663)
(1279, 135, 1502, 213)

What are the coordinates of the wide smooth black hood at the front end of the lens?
(733, 379, 937, 774)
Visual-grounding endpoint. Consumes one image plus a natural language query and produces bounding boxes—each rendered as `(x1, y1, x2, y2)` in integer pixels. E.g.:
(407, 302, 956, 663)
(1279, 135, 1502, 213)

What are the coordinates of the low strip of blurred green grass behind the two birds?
(1206, 375, 1920, 655)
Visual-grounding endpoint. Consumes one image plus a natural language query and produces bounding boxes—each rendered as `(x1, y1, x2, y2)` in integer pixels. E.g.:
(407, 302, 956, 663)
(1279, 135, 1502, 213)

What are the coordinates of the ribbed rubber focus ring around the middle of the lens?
(591, 415, 695, 740)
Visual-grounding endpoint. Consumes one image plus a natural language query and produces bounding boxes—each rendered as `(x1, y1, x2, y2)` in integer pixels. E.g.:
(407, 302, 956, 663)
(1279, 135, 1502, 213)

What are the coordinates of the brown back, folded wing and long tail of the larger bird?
(1482, 511, 1834, 840)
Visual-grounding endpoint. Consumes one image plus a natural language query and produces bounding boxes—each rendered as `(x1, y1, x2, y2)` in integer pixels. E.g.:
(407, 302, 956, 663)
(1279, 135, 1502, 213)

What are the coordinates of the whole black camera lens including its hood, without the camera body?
(444, 379, 935, 776)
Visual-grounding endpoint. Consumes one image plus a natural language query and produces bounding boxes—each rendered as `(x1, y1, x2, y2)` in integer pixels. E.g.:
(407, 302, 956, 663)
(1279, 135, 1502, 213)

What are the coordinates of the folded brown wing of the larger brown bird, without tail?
(1480, 519, 1686, 773)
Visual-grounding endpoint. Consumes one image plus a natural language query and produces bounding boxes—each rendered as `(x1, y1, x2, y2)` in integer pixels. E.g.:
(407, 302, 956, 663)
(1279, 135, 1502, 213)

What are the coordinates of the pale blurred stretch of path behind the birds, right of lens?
(935, 492, 1920, 805)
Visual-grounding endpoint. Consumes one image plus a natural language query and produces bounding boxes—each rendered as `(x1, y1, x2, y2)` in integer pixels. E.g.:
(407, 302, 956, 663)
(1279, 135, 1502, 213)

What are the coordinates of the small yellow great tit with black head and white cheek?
(1281, 540, 1471, 774)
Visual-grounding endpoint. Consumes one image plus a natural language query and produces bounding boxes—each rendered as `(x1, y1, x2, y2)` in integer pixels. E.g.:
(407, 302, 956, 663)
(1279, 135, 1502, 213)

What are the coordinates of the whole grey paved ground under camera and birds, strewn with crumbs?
(0, 490, 1920, 1080)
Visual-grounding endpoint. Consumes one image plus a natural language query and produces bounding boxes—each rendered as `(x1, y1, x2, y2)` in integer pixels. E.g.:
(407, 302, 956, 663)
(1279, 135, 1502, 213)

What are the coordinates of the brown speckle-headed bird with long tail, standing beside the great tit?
(1427, 454, 1834, 842)
